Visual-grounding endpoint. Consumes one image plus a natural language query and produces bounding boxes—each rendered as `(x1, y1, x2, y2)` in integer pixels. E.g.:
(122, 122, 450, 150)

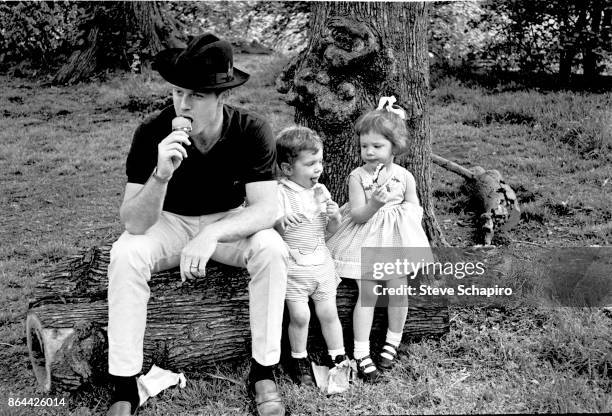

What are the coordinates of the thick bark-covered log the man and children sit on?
(26, 246, 449, 392)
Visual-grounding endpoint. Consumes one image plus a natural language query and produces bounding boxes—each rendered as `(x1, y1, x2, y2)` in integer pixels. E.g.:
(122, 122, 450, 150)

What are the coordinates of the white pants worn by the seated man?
(108, 210, 288, 376)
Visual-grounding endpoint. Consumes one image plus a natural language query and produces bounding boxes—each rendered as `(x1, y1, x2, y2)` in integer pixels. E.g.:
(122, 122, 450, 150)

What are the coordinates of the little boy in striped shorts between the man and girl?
(275, 127, 346, 385)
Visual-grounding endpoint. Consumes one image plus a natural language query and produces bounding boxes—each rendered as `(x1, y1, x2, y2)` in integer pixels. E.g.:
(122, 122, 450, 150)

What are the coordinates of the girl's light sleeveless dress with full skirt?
(327, 164, 433, 280)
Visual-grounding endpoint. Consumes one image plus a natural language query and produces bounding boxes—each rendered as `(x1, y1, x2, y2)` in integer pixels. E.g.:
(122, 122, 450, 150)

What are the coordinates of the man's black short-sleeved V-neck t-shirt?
(126, 105, 276, 216)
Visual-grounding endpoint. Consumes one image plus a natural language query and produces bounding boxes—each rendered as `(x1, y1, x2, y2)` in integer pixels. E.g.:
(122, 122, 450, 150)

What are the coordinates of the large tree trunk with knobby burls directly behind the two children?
(277, 2, 447, 246)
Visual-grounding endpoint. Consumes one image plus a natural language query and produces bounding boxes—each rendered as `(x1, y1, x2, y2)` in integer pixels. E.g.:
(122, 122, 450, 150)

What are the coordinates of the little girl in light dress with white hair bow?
(327, 97, 431, 381)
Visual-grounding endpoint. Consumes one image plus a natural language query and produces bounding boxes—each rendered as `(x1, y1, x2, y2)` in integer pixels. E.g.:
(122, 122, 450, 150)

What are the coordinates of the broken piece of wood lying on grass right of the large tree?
(431, 153, 521, 245)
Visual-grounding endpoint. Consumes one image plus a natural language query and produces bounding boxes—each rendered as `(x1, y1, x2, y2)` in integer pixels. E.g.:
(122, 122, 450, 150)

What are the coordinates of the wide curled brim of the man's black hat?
(153, 48, 250, 92)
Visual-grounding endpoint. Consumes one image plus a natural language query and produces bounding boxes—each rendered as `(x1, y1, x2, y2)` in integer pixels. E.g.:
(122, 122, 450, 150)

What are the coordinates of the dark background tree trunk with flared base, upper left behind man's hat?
(53, 1, 182, 84)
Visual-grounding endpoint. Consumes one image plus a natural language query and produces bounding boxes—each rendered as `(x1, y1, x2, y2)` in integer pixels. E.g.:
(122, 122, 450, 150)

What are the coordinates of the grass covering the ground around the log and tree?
(0, 56, 612, 416)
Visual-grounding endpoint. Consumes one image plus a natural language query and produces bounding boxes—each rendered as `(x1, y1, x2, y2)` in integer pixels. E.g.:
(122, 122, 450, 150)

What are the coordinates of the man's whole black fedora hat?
(153, 33, 249, 92)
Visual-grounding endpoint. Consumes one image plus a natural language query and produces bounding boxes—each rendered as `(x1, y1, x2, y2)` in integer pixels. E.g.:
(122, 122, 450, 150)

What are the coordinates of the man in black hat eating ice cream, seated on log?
(108, 34, 288, 415)
